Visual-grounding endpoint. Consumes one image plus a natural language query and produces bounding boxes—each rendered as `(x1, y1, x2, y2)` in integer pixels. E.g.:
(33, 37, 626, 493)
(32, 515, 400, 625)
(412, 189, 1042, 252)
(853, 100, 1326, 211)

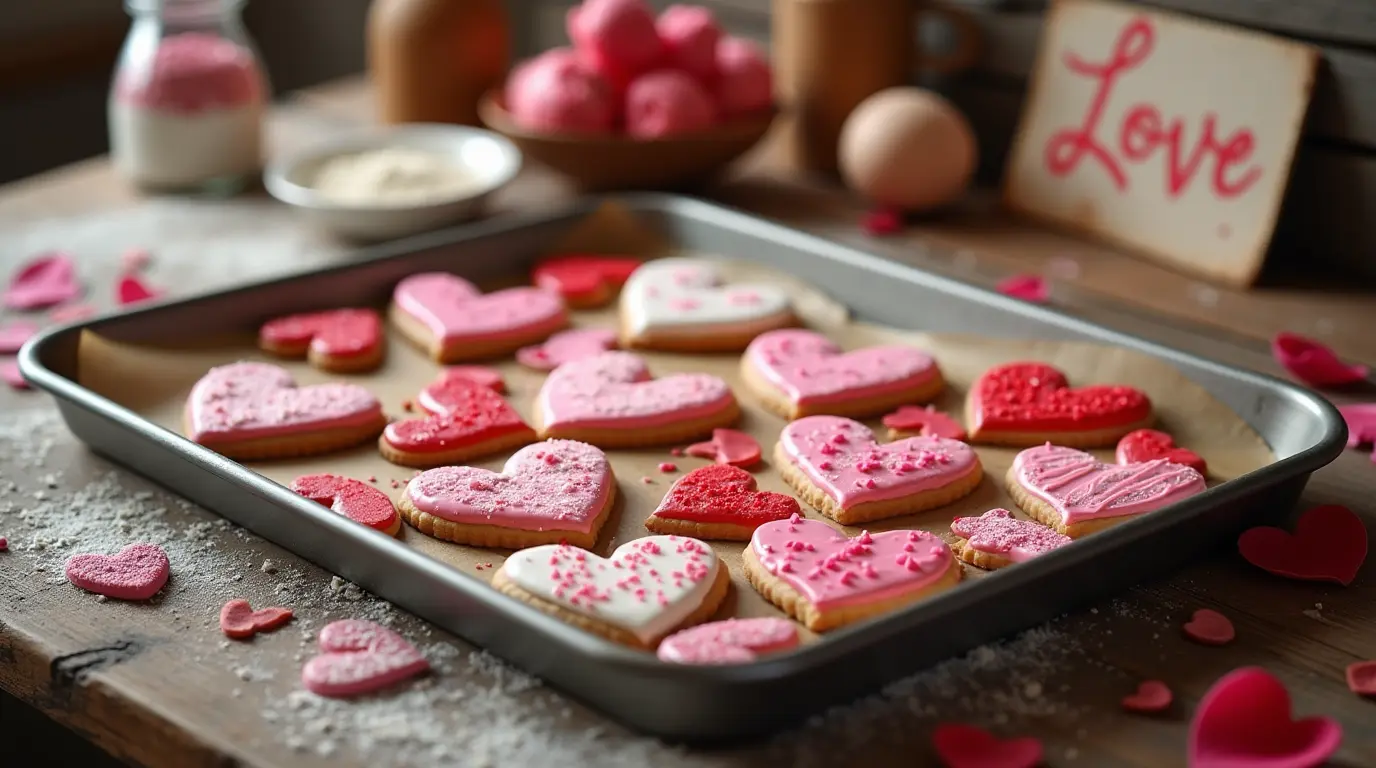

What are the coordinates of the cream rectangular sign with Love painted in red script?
(1003, 0, 1318, 285)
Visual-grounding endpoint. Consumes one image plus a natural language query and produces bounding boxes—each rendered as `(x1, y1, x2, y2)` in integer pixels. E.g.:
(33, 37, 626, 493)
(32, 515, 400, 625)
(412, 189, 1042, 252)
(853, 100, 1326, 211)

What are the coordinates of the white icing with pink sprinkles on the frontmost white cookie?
(502, 535, 721, 643)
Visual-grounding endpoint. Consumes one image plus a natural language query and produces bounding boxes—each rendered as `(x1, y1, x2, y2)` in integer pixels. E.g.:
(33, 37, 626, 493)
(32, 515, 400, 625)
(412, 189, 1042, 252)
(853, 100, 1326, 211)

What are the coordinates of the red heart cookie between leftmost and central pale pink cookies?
(377, 374, 535, 468)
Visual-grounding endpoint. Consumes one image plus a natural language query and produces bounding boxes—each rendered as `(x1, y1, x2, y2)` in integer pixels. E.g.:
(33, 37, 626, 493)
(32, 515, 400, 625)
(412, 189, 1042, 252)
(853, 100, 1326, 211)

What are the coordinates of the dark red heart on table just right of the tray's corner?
(1237, 504, 1366, 586)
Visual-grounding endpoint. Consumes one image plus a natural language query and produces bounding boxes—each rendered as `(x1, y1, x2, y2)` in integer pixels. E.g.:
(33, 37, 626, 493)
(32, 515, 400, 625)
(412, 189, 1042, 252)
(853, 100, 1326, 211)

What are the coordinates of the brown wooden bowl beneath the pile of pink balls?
(477, 91, 776, 191)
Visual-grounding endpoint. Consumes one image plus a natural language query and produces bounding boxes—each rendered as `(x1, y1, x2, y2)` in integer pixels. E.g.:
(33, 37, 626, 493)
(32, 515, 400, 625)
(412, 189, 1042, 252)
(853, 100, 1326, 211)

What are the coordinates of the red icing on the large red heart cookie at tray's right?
(970, 362, 1152, 432)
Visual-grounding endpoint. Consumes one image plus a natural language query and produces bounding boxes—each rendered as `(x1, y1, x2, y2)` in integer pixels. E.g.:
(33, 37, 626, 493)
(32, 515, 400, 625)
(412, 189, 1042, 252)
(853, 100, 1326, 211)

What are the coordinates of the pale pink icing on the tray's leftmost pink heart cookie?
(186, 362, 383, 445)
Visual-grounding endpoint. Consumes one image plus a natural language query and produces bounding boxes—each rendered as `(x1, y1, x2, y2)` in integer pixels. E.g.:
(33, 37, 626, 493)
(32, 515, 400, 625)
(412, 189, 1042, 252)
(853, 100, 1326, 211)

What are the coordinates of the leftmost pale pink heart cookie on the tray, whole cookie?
(186, 362, 387, 458)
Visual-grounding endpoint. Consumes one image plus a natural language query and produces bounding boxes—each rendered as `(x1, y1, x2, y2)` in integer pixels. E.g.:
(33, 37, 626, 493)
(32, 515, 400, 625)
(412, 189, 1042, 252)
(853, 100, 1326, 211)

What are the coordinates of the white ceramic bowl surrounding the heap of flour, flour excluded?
(263, 124, 522, 241)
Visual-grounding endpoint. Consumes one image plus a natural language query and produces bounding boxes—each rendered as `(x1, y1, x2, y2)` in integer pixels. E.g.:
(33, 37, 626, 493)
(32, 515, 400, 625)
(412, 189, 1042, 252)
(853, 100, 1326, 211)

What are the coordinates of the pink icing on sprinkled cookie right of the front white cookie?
(750, 516, 955, 610)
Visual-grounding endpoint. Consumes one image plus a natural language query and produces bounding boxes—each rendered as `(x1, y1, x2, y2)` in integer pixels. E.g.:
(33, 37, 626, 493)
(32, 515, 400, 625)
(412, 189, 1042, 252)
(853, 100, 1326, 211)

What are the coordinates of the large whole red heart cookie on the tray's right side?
(965, 362, 1152, 447)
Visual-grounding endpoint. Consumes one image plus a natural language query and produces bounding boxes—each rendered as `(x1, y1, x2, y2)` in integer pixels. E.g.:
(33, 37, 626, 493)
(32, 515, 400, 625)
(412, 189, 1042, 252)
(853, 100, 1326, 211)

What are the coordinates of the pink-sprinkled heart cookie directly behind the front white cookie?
(398, 440, 616, 549)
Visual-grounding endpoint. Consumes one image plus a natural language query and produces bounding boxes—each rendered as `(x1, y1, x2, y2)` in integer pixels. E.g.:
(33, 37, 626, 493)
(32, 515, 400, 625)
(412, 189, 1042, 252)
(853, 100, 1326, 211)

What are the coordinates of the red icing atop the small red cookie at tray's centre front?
(655, 464, 801, 527)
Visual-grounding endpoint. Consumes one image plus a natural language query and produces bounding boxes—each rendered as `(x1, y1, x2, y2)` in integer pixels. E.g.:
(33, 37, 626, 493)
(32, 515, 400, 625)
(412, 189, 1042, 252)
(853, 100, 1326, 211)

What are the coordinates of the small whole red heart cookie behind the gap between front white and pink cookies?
(645, 464, 801, 541)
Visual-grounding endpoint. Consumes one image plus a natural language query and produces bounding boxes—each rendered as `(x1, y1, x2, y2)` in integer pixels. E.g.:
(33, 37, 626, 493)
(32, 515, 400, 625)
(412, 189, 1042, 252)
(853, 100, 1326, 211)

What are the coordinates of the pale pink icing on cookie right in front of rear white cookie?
(539, 352, 733, 429)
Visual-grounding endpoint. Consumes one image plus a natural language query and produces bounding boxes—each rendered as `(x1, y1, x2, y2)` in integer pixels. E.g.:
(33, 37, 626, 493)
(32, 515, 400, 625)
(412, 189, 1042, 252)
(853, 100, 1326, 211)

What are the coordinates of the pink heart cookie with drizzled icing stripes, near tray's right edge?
(1007, 443, 1205, 538)
